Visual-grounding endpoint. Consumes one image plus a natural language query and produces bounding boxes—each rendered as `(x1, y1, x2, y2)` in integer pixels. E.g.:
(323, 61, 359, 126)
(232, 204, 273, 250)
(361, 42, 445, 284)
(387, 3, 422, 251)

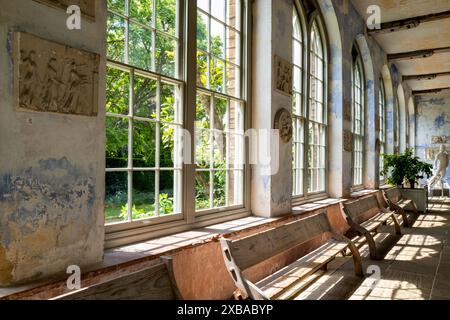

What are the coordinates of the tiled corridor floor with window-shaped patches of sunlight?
(295, 197, 450, 300)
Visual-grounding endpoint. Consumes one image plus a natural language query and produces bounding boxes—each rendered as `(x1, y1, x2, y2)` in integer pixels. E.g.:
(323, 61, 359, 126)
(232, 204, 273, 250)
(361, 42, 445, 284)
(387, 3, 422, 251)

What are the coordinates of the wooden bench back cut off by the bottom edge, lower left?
(51, 257, 182, 300)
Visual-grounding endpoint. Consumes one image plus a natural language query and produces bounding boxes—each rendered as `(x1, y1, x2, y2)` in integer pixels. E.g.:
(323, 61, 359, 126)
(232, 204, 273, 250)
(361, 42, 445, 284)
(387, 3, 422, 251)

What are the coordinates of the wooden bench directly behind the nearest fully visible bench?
(343, 195, 401, 260)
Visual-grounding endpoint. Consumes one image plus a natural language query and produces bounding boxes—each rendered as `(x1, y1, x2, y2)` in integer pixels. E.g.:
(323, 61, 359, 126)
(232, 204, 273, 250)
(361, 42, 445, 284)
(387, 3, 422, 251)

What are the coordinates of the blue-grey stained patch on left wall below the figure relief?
(0, 157, 96, 247)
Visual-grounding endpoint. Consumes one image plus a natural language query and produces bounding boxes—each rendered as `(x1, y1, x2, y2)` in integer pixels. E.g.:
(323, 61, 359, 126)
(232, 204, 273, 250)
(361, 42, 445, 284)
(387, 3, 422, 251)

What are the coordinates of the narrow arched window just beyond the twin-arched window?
(352, 50, 365, 187)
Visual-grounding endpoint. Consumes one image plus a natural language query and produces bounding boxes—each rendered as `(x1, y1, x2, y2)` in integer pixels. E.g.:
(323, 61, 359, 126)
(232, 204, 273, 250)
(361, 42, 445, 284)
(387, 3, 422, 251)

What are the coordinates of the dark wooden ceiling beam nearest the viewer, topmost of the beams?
(367, 10, 450, 34)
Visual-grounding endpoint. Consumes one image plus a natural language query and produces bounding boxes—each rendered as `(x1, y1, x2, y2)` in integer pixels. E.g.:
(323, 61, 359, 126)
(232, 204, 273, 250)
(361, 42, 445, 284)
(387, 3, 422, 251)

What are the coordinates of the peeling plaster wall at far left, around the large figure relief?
(0, 0, 106, 285)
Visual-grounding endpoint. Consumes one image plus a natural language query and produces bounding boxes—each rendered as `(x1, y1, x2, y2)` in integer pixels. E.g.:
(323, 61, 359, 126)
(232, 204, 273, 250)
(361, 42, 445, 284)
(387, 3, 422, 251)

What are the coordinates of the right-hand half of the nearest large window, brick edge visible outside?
(195, 0, 244, 213)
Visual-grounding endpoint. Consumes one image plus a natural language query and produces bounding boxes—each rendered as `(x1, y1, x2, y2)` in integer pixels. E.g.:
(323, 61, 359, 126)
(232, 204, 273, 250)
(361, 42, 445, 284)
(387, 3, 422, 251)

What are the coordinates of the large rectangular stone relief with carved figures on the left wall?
(14, 32, 100, 116)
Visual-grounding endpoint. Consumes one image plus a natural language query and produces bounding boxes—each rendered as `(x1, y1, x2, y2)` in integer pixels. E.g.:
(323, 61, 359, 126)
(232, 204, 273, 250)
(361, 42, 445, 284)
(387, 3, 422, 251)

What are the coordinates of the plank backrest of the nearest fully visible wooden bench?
(224, 212, 331, 270)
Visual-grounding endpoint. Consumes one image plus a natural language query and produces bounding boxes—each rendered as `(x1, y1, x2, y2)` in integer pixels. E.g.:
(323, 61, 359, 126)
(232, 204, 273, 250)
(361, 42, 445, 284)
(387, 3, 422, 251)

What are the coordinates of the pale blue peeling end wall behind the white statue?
(415, 91, 450, 179)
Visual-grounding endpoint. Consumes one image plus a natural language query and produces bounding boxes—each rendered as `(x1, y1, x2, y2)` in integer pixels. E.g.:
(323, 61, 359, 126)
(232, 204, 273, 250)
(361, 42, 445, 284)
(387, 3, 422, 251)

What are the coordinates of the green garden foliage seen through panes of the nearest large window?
(105, 0, 232, 216)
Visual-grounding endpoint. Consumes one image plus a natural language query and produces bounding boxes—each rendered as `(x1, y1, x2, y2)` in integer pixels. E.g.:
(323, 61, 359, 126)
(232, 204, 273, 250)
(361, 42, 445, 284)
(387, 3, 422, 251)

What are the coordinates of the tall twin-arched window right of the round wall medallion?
(293, 8, 327, 197)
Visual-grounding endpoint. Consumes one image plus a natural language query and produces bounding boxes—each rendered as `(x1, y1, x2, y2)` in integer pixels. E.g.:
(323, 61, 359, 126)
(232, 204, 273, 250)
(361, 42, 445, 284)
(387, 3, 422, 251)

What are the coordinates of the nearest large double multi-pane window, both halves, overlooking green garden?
(105, 0, 247, 234)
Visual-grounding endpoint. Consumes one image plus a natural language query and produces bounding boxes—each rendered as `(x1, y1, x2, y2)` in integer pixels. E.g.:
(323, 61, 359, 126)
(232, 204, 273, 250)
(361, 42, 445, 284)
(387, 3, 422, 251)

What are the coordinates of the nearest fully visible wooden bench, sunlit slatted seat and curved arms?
(221, 212, 363, 300)
